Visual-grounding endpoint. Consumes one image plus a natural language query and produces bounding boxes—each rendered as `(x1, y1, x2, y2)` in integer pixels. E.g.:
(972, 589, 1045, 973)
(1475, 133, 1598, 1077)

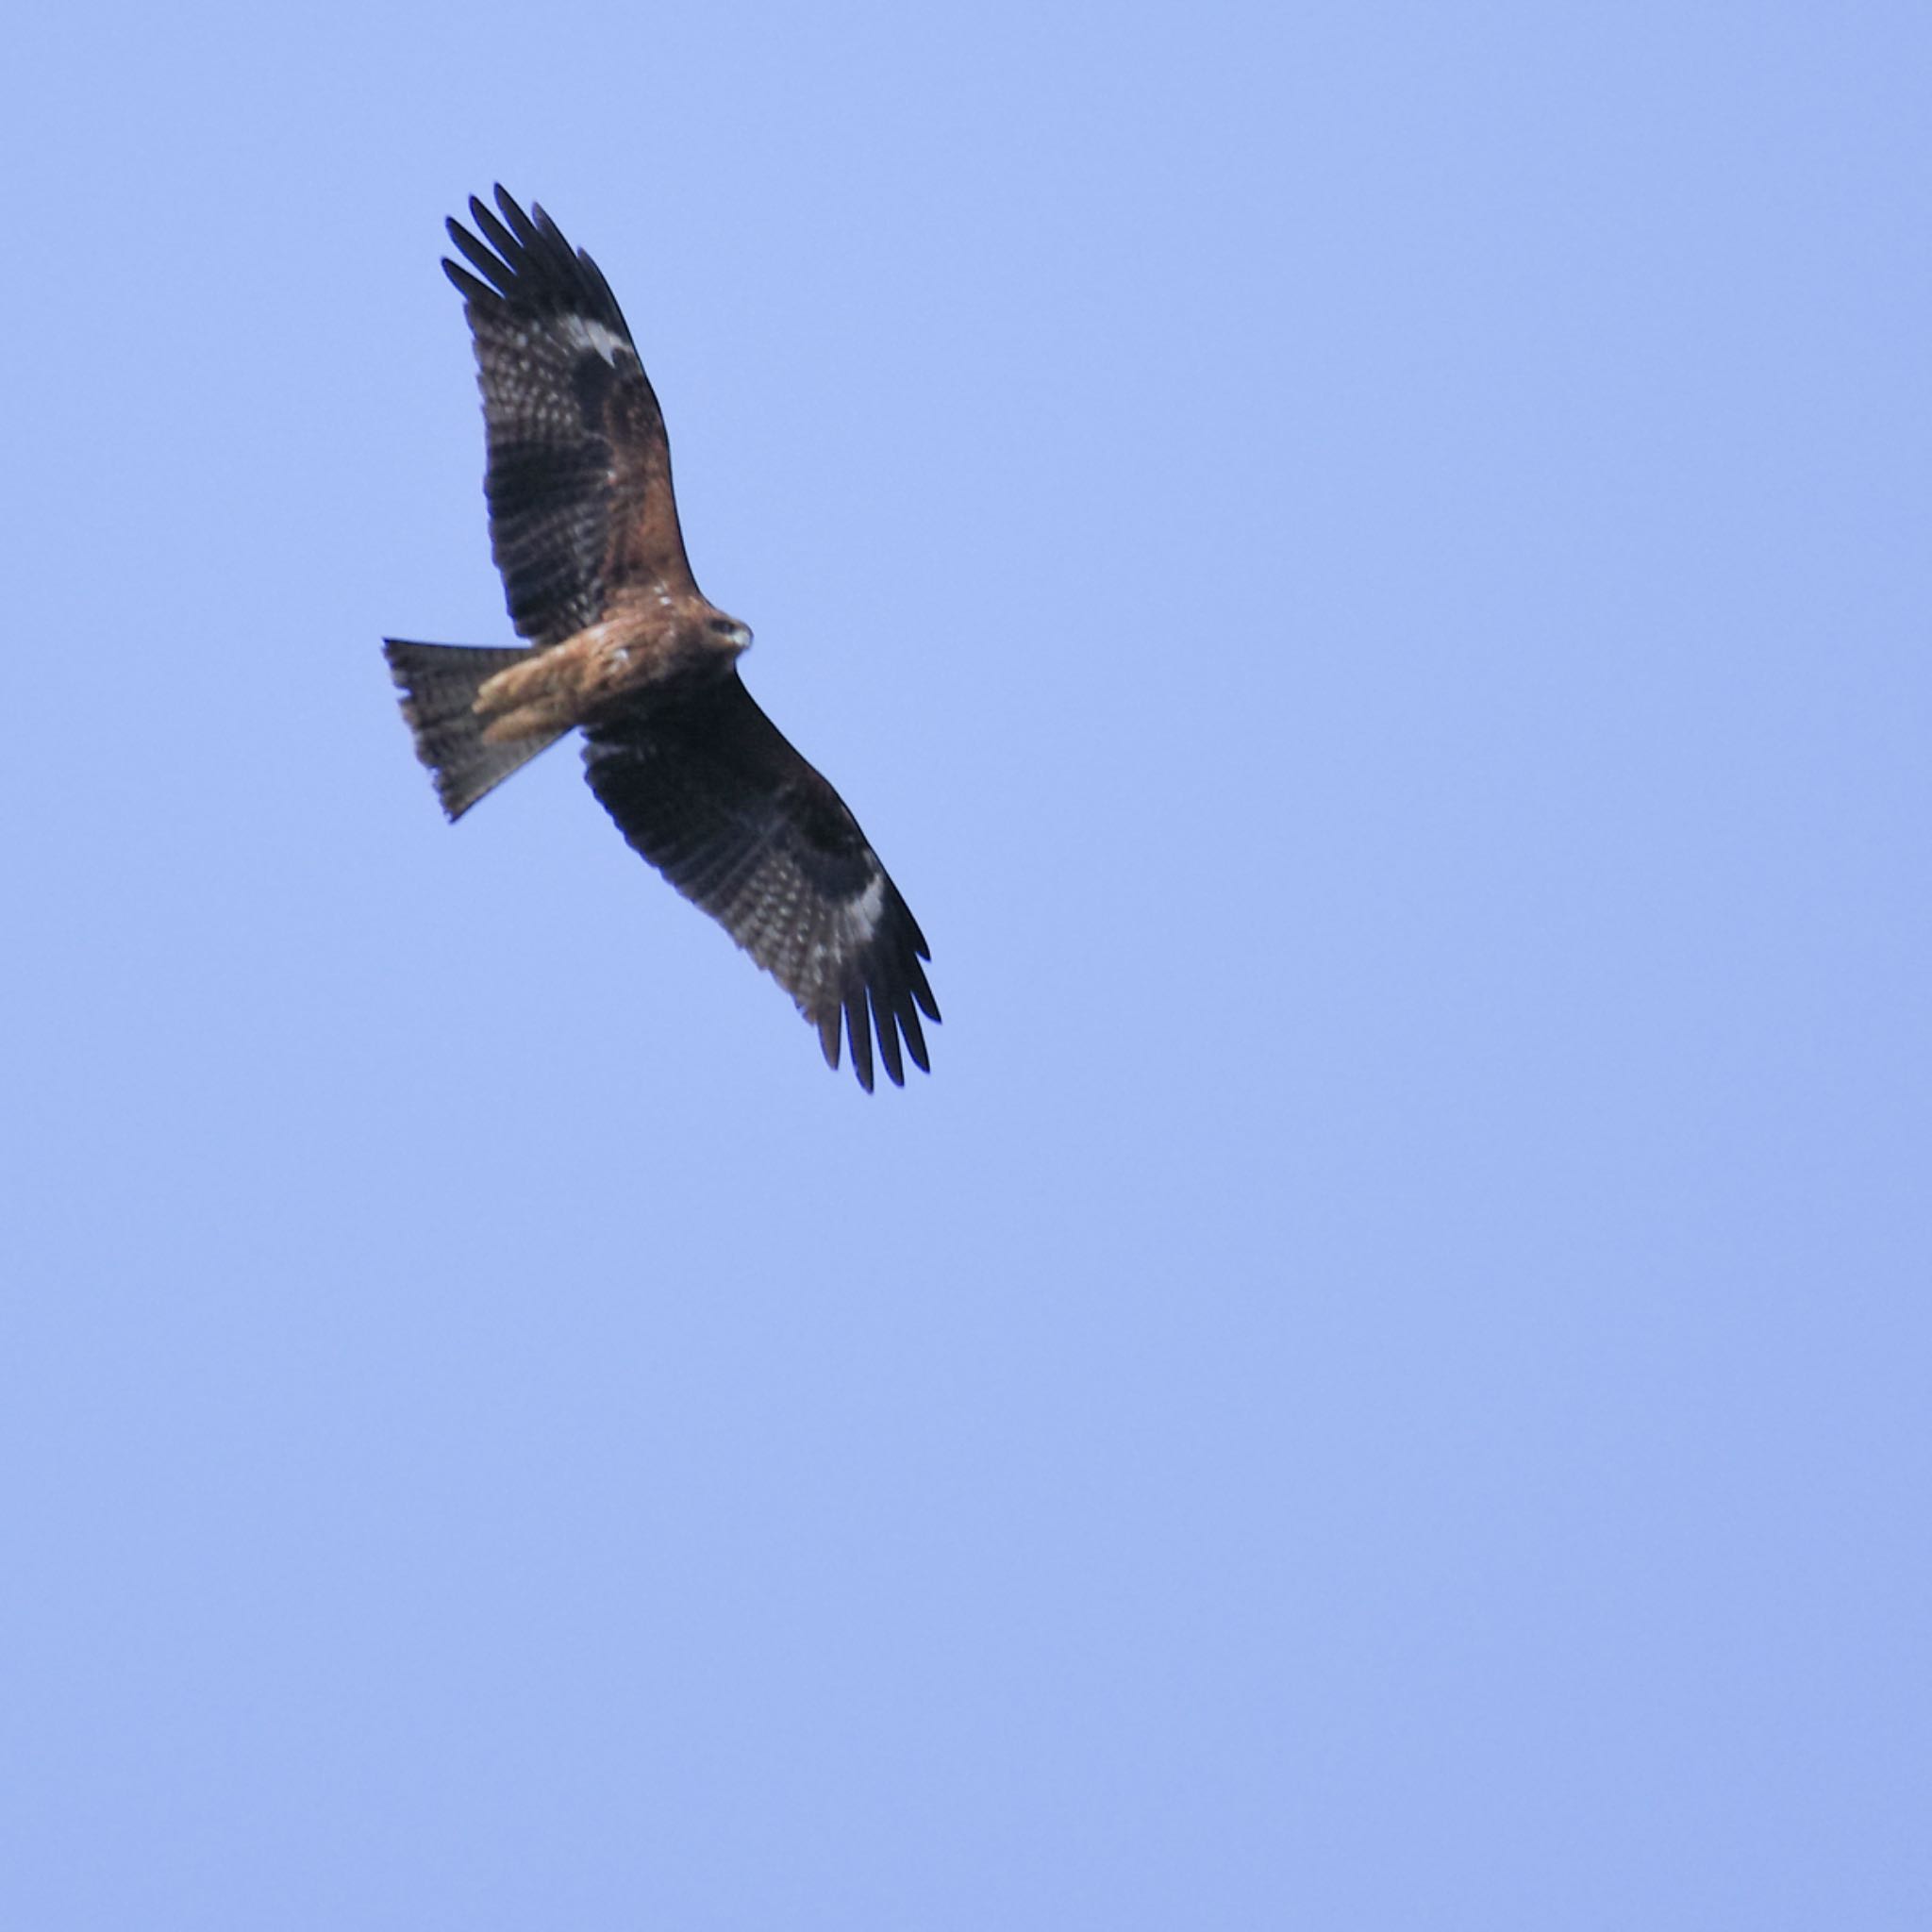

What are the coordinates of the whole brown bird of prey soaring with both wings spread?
(385, 188, 939, 1093)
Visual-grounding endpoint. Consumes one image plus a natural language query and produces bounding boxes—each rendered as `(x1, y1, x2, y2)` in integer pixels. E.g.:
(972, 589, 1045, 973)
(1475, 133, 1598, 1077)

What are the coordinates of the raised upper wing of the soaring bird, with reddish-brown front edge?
(442, 188, 695, 645)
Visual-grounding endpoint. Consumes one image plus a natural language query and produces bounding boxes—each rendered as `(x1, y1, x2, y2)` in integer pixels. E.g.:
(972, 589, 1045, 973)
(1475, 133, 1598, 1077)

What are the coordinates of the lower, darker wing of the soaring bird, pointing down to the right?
(583, 673, 939, 1093)
